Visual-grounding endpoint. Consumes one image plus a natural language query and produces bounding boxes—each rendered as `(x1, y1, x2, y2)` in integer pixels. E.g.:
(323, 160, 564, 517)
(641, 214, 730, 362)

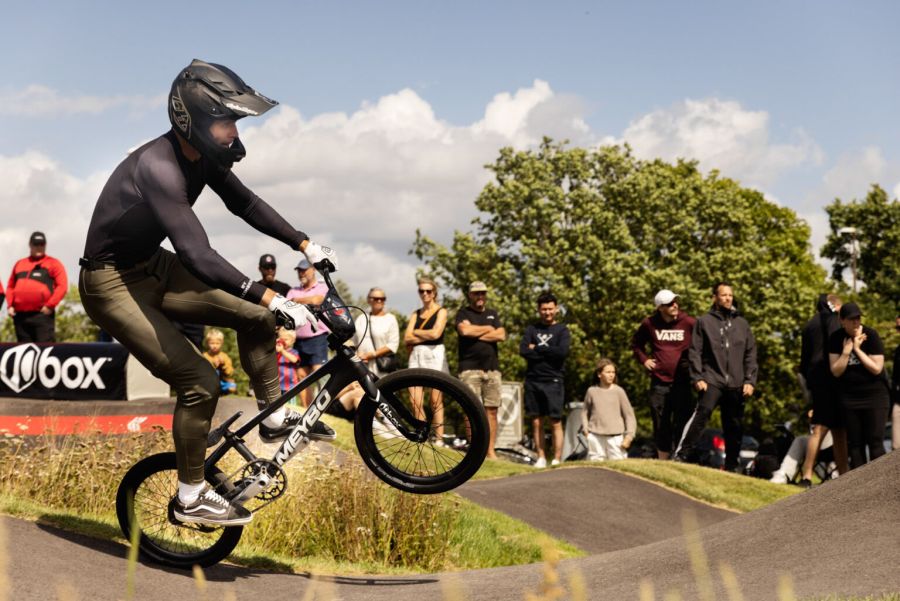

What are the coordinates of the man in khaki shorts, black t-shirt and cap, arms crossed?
(456, 282, 506, 459)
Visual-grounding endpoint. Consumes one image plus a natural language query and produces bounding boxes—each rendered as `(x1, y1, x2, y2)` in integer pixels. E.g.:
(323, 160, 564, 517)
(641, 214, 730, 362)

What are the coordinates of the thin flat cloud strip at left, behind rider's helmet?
(0, 85, 166, 117)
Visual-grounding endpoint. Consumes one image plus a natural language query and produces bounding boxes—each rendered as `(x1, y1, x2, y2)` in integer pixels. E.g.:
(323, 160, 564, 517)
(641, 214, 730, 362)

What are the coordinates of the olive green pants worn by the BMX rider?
(78, 249, 281, 484)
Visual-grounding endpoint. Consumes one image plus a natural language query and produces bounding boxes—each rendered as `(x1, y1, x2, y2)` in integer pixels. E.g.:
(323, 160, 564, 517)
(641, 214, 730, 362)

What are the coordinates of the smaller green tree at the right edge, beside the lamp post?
(822, 184, 900, 320)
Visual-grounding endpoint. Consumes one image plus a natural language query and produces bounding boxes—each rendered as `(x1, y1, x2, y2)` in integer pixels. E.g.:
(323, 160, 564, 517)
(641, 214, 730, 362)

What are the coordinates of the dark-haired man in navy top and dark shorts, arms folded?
(519, 292, 571, 467)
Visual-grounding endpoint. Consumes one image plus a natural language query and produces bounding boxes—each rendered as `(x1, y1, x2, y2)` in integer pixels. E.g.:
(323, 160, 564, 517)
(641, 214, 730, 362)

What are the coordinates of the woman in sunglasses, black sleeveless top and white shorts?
(403, 278, 450, 445)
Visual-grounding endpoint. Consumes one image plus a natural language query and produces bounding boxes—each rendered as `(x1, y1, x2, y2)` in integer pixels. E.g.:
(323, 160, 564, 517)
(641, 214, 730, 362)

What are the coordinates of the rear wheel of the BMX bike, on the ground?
(116, 453, 243, 569)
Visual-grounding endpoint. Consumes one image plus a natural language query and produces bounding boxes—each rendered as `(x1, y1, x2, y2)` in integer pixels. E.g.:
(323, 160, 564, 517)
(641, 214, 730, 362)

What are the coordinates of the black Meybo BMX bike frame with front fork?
(204, 335, 430, 472)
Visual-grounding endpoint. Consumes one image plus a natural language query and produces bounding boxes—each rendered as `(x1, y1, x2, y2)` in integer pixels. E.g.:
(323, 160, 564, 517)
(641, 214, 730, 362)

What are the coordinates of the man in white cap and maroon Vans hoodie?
(631, 290, 695, 459)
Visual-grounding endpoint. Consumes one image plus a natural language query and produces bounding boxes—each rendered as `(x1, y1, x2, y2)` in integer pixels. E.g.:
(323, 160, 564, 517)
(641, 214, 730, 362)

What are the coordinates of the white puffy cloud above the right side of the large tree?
(622, 98, 823, 187)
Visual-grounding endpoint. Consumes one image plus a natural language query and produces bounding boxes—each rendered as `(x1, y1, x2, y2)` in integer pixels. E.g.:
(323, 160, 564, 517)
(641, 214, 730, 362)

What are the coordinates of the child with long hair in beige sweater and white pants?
(581, 358, 637, 461)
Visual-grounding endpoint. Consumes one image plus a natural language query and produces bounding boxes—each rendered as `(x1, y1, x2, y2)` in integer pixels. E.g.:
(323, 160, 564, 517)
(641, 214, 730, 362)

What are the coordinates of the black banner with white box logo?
(0, 342, 128, 400)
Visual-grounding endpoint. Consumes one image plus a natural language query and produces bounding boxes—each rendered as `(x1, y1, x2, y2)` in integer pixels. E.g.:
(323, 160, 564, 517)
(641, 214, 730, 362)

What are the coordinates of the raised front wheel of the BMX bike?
(354, 368, 489, 494)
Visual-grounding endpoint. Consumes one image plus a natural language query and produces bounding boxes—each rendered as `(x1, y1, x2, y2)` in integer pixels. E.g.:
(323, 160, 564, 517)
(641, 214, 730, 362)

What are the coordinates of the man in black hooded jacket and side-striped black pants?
(673, 282, 757, 471)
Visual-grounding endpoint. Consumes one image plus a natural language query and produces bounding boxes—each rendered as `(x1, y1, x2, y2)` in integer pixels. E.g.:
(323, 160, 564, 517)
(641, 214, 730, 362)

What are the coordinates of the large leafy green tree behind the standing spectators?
(413, 138, 825, 434)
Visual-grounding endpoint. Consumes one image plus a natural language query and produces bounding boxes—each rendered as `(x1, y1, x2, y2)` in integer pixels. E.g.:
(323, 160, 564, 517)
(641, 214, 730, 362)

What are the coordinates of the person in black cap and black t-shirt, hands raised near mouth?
(828, 303, 889, 470)
